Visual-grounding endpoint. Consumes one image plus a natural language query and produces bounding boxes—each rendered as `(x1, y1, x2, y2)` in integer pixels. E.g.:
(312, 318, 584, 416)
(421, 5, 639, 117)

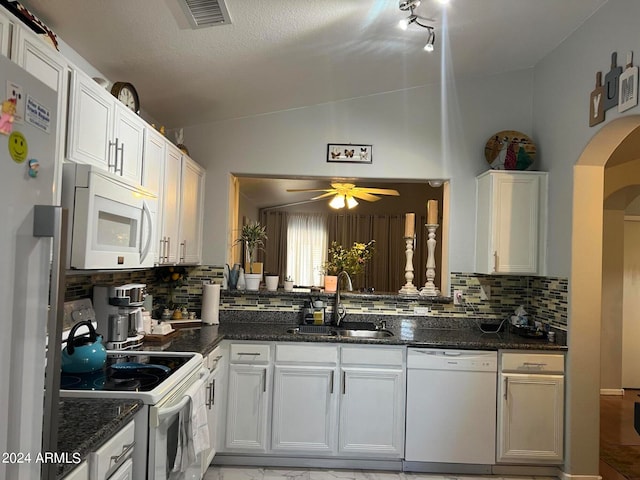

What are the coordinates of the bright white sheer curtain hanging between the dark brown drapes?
(286, 213, 328, 286)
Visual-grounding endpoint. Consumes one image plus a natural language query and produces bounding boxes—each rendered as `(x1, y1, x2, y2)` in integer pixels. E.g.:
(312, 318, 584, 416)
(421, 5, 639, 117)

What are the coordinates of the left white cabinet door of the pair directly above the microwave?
(67, 71, 115, 172)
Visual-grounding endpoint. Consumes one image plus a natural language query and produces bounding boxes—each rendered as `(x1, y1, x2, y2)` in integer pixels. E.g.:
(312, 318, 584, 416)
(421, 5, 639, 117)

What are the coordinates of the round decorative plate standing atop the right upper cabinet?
(484, 130, 536, 170)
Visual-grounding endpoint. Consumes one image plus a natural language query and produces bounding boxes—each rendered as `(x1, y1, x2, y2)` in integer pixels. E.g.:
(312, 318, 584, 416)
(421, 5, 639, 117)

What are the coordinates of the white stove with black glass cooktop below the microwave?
(60, 301, 211, 480)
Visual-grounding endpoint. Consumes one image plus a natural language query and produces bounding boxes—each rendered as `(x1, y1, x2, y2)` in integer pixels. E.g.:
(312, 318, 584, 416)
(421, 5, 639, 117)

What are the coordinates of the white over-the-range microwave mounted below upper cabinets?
(62, 163, 158, 269)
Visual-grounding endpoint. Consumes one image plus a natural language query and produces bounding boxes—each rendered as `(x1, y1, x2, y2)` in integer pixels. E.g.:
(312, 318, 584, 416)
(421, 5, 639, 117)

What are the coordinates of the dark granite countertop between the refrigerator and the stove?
(56, 398, 142, 479)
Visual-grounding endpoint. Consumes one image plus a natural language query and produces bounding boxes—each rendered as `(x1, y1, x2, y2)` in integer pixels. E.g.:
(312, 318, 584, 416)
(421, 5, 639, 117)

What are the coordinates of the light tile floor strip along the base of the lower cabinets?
(203, 467, 555, 480)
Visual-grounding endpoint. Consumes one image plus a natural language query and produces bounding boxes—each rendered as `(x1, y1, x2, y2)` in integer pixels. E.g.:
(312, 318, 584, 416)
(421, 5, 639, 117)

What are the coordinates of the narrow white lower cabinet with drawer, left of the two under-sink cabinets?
(225, 343, 271, 453)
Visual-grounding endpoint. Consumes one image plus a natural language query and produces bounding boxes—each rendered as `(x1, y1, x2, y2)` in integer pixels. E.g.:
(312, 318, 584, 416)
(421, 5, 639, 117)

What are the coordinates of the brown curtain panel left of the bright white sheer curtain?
(258, 211, 288, 283)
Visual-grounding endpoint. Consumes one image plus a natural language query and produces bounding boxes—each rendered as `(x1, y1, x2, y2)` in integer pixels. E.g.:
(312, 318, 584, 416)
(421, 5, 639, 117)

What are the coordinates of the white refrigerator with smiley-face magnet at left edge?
(0, 55, 64, 480)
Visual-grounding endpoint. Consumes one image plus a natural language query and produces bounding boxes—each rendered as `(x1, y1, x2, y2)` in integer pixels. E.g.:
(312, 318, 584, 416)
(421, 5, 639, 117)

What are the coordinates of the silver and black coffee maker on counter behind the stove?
(93, 283, 147, 350)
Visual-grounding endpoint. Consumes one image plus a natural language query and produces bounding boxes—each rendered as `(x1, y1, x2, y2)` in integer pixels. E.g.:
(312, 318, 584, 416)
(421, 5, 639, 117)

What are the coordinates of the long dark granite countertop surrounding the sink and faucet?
(145, 314, 567, 356)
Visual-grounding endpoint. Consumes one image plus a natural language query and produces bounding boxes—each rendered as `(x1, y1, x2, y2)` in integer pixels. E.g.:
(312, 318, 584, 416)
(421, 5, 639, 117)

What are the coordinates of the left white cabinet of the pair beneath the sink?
(271, 344, 339, 455)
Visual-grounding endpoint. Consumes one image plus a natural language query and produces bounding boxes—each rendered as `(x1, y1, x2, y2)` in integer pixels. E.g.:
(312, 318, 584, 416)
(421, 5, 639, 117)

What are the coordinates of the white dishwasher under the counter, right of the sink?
(403, 348, 498, 473)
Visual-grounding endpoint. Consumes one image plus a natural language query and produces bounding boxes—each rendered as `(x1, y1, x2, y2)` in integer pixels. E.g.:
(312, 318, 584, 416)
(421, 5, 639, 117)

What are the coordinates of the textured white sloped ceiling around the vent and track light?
(22, 0, 606, 128)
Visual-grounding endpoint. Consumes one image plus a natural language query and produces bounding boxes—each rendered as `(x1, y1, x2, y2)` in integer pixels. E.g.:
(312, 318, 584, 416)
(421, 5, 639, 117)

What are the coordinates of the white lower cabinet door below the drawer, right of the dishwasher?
(497, 373, 564, 464)
